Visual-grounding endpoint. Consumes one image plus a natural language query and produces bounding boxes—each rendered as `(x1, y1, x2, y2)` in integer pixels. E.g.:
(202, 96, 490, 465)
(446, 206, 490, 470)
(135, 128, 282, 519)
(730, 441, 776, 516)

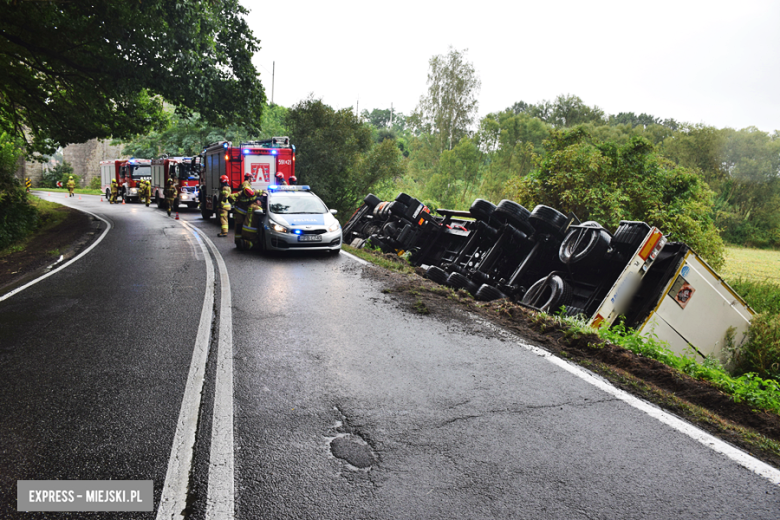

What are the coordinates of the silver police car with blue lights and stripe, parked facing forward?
(263, 186, 341, 253)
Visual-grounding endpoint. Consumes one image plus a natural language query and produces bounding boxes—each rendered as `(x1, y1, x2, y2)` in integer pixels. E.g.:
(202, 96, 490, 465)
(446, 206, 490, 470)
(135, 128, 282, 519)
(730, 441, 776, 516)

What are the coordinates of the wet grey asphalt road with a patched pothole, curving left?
(0, 194, 780, 520)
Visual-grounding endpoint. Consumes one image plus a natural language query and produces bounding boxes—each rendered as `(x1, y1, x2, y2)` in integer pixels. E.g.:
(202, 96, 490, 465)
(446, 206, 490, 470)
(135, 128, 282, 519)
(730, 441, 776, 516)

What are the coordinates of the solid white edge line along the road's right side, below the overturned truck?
(475, 318, 780, 485)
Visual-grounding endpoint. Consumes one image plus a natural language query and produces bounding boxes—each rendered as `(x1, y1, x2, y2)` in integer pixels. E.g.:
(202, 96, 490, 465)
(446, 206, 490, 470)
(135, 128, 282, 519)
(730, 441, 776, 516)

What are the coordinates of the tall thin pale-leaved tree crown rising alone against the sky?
(409, 47, 481, 153)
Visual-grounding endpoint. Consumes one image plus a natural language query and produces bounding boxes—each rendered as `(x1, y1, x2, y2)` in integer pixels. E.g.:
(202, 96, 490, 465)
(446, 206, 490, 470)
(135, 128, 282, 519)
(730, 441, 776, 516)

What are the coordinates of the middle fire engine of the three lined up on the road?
(152, 156, 201, 211)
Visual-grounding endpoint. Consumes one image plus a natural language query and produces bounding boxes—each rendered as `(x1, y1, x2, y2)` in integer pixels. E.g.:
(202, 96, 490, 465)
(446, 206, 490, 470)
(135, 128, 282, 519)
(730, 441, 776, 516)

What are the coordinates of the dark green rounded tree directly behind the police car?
(286, 98, 403, 219)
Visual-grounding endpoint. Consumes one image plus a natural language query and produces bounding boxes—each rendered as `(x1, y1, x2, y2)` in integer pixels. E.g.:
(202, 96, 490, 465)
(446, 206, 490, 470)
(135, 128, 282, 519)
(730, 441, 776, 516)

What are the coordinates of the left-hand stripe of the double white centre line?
(157, 221, 214, 520)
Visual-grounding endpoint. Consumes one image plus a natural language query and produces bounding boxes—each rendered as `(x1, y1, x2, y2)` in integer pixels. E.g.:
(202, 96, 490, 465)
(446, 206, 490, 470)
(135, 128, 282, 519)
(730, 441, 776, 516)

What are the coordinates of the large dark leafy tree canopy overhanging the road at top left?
(0, 0, 265, 154)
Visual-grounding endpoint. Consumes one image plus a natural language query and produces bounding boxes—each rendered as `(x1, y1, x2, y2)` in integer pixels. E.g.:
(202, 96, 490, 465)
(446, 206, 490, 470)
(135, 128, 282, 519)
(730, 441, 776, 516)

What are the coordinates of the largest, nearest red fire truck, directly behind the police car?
(200, 137, 295, 219)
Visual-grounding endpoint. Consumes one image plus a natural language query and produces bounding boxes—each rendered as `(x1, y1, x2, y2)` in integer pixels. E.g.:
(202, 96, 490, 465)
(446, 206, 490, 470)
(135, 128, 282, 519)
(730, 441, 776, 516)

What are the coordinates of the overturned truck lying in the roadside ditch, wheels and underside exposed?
(343, 193, 753, 358)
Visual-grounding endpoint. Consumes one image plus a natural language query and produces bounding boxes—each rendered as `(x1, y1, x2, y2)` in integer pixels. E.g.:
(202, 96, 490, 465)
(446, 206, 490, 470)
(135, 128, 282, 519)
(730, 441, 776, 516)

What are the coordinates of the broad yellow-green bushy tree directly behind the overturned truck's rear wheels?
(513, 127, 724, 268)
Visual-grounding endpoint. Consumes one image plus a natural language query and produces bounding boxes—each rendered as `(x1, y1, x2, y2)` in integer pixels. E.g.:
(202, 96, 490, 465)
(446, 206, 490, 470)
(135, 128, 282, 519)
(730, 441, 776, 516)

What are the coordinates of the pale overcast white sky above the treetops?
(240, 0, 780, 132)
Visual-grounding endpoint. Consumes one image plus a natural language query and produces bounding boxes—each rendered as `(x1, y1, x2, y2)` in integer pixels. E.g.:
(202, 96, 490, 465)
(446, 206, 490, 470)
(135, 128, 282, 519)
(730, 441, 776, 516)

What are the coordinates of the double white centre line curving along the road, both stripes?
(157, 221, 234, 520)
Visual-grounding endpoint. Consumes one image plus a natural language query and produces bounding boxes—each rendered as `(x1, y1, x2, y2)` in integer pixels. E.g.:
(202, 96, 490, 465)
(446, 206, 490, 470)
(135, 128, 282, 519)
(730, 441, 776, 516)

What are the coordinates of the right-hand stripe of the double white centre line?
(186, 222, 235, 520)
